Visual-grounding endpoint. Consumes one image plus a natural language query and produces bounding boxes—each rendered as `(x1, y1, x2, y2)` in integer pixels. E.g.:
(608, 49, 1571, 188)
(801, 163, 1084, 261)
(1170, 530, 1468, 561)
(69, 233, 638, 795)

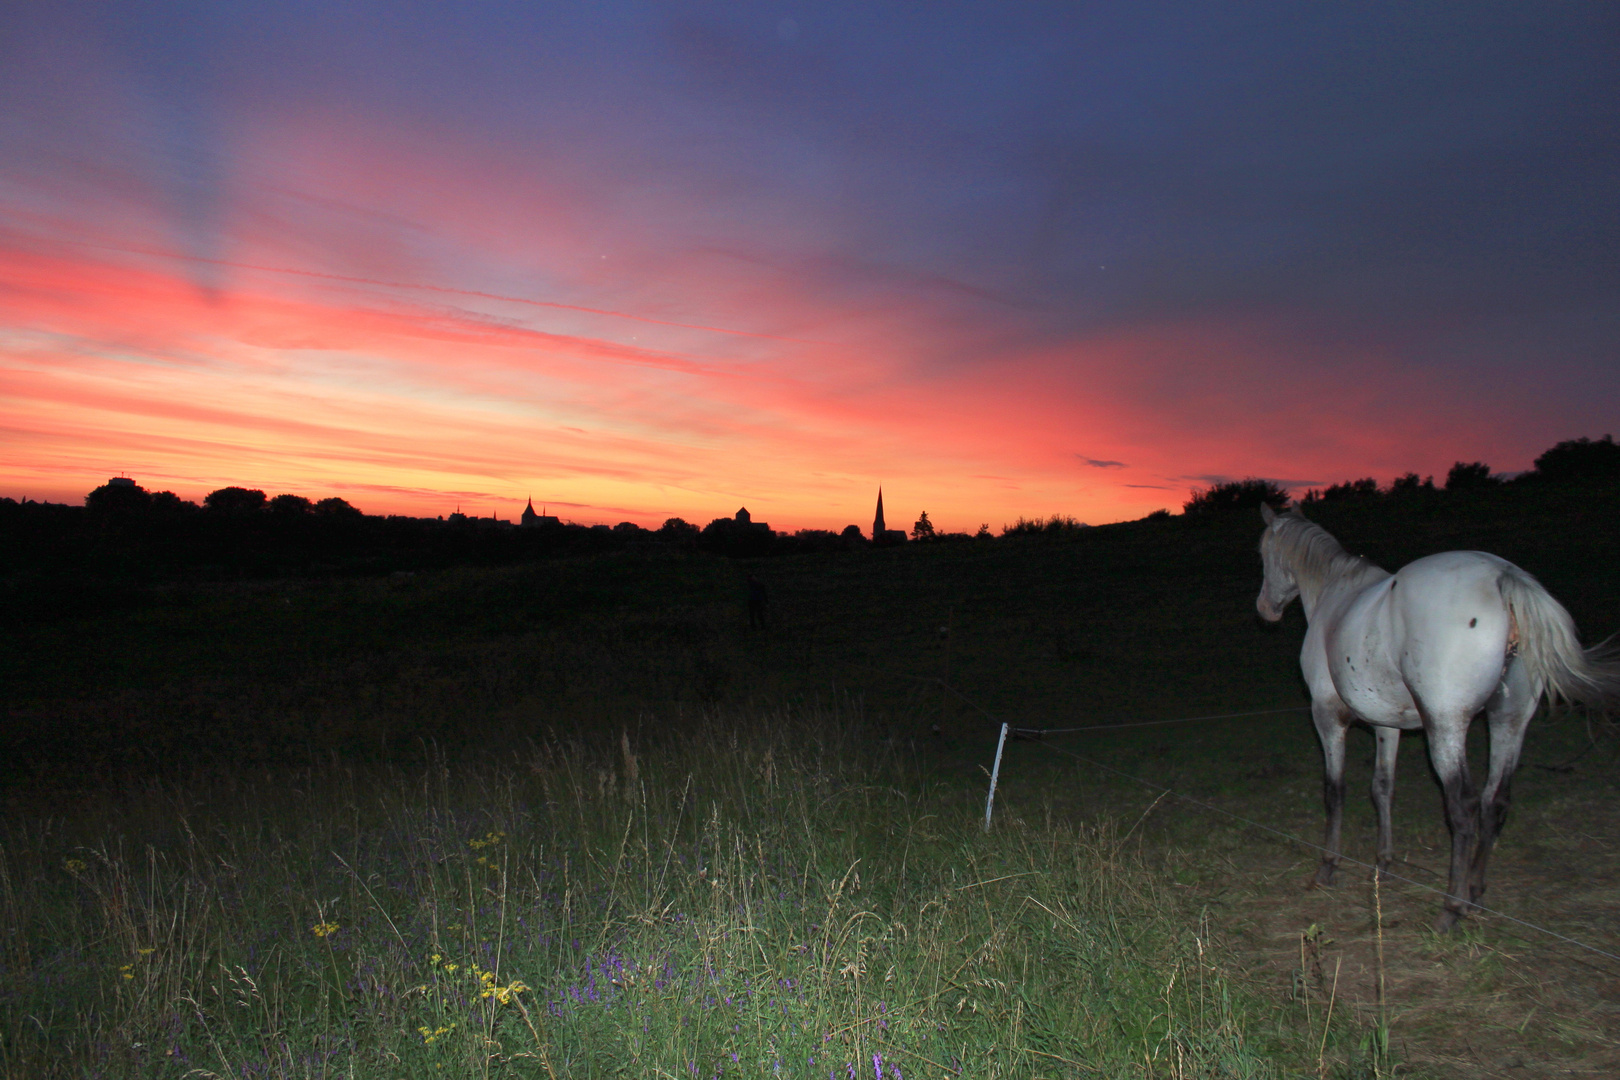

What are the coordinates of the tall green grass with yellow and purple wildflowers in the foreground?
(0, 709, 1298, 1080)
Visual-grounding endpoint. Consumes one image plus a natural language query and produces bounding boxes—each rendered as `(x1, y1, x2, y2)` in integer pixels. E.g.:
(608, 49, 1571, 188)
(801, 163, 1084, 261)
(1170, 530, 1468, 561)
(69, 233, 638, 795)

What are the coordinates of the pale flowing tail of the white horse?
(1497, 565, 1620, 708)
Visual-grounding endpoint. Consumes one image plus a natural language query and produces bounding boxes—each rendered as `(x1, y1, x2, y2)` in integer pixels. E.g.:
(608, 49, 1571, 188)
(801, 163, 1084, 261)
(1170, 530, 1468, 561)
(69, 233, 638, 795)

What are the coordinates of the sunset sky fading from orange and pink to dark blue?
(0, 0, 1620, 531)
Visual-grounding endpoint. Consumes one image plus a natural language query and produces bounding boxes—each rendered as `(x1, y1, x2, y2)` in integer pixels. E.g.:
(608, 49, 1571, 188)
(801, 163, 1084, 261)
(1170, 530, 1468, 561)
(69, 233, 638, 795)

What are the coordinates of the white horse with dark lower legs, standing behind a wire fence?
(1256, 507, 1620, 933)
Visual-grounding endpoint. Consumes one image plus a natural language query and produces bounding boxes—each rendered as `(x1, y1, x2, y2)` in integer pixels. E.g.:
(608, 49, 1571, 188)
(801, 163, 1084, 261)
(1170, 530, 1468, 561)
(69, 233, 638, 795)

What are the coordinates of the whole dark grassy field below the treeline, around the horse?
(0, 491, 1620, 1077)
